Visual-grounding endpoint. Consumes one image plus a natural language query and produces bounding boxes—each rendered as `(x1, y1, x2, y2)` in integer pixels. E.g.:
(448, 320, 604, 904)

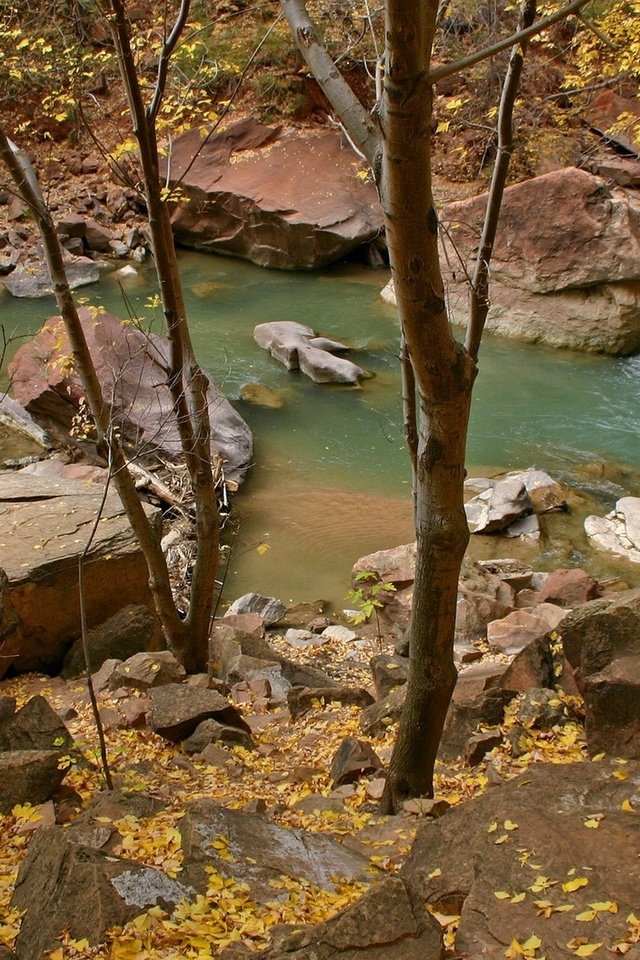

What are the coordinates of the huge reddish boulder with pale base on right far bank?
(385, 167, 640, 354)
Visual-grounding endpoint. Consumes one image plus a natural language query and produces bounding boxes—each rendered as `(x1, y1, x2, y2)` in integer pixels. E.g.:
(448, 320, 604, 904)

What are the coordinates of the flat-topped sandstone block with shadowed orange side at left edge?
(0, 472, 160, 677)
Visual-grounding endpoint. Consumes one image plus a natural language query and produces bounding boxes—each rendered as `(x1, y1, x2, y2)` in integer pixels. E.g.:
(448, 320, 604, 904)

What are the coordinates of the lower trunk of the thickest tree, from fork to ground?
(382, 378, 471, 813)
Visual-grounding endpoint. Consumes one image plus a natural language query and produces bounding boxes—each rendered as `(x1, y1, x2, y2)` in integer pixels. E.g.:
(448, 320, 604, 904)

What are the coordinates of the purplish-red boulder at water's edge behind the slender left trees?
(8, 307, 252, 481)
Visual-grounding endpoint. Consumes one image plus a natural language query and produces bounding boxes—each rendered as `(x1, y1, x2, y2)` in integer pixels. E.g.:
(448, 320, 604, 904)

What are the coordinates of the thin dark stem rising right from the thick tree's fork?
(465, 0, 536, 362)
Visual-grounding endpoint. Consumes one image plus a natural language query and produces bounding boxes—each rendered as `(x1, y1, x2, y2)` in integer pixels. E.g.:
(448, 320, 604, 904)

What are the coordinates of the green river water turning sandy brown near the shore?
(0, 253, 640, 604)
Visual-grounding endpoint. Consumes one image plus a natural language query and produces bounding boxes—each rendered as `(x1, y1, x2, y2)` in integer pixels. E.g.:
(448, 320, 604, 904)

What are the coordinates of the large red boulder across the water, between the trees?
(165, 119, 383, 270)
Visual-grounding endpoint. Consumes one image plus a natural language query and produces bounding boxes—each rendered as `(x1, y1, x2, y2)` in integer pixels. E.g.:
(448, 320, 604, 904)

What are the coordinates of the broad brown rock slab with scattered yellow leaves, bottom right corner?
(400, 761, 640, 960)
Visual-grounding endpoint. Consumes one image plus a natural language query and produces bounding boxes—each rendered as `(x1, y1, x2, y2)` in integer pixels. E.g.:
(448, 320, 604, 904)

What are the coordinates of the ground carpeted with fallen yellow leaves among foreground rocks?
(0, 640, 596, 960)
